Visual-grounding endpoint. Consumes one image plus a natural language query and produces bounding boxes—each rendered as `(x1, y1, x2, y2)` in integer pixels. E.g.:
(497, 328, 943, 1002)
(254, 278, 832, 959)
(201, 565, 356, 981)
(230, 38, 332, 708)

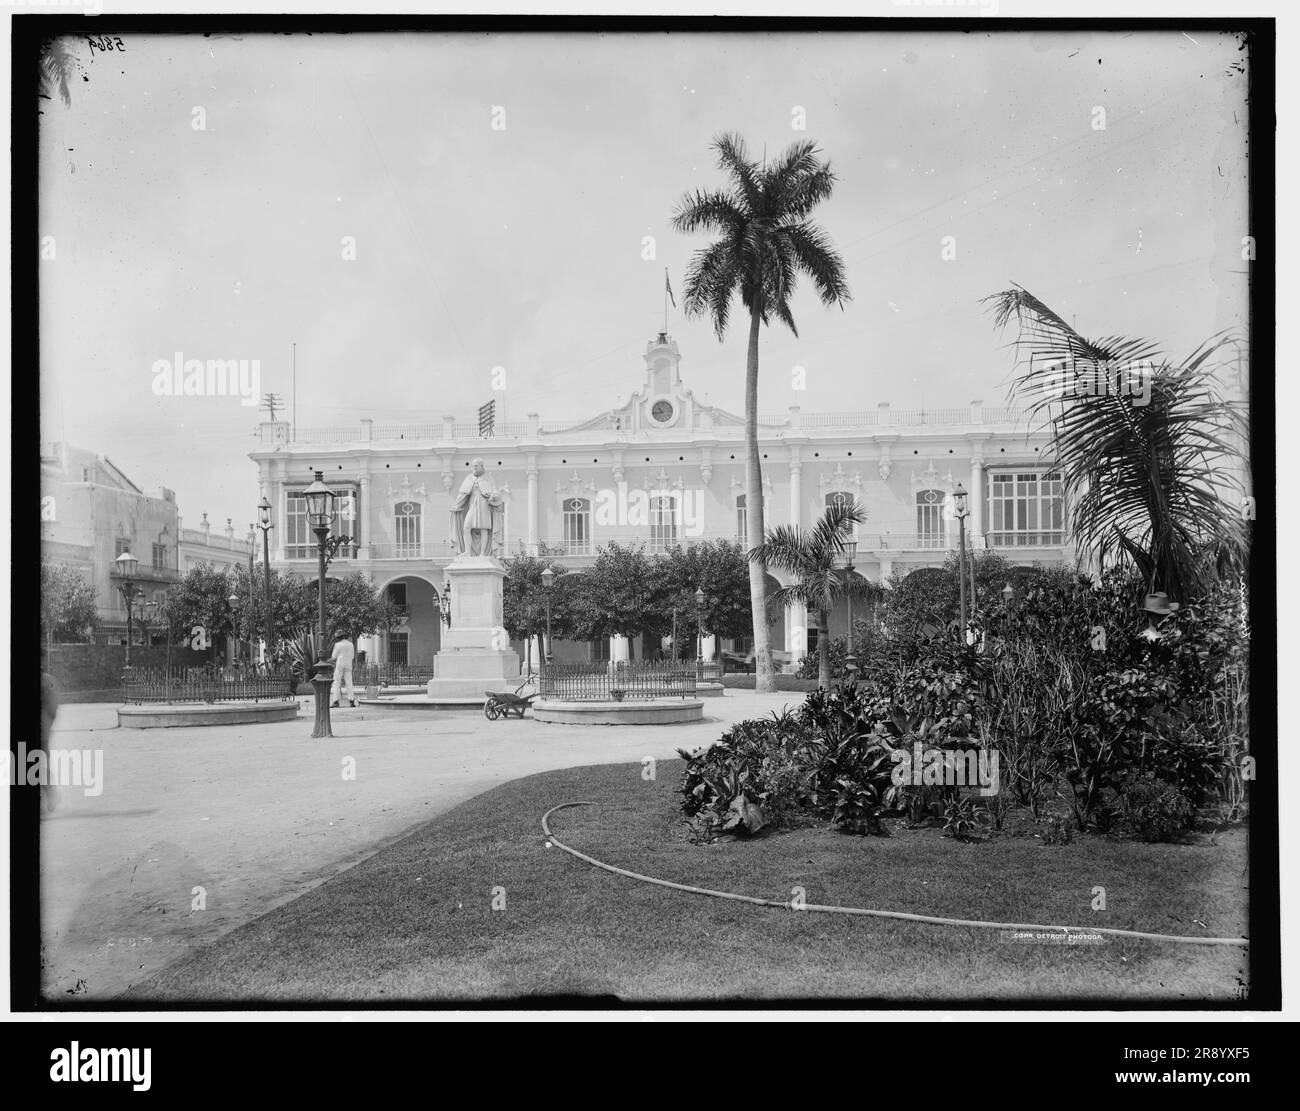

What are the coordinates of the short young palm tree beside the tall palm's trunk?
(758, 502, 876, 687)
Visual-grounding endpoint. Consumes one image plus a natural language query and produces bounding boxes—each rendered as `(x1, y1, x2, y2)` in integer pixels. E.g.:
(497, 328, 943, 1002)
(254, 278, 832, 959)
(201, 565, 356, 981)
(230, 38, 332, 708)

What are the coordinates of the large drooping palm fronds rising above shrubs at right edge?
(985, 286, 1247, 600)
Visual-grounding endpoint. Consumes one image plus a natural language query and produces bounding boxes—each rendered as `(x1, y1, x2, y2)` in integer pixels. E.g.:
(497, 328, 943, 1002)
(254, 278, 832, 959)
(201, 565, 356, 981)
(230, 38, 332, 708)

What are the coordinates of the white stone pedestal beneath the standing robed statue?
(428, 555, 520, 700)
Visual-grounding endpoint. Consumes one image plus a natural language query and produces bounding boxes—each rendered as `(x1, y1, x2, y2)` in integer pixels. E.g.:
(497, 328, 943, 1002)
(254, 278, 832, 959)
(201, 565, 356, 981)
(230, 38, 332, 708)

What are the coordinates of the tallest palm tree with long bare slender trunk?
(672, 134, 849, 691)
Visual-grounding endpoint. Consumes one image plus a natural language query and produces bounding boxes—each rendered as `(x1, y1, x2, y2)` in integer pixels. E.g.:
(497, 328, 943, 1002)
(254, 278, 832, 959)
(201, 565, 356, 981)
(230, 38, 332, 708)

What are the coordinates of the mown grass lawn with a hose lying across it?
(124, 760, 1248, 1006)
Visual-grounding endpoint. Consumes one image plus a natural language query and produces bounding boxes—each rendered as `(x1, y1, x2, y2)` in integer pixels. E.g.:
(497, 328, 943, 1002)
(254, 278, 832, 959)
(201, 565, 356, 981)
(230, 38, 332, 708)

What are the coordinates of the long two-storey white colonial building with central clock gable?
(250, 333, 1073, 663)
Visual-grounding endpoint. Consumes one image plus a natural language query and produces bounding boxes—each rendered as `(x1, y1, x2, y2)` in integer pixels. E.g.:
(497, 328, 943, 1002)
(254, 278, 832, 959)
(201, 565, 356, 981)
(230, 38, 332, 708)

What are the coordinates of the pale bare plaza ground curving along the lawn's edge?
(40, 690, 803, 1001)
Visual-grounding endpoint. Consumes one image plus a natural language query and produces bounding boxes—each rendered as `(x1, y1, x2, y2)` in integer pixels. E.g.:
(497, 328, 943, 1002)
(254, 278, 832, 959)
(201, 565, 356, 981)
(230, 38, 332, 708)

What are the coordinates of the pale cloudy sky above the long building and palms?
(39, 30, 1249, 529)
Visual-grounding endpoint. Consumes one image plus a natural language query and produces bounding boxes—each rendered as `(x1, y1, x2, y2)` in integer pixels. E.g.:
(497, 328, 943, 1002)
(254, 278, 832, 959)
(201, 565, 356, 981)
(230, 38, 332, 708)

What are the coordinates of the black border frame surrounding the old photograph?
(9, 13, 1282, 1018)
